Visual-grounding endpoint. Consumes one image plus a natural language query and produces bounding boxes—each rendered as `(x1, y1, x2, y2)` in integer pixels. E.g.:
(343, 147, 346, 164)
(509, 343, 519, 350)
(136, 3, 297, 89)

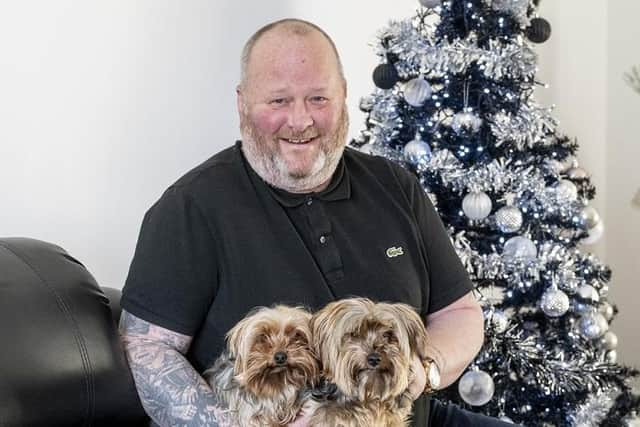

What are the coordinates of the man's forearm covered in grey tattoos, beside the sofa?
(120, 310, 232, 427)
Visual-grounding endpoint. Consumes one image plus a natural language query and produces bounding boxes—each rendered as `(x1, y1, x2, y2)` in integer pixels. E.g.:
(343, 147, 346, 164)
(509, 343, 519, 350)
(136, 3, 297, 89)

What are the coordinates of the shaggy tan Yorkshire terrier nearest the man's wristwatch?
(308, 298, 427, 427)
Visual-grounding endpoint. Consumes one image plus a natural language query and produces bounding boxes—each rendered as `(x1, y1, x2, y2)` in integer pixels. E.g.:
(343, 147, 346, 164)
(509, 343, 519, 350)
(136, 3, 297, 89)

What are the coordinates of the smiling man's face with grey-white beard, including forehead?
(238, 29, 348, 192)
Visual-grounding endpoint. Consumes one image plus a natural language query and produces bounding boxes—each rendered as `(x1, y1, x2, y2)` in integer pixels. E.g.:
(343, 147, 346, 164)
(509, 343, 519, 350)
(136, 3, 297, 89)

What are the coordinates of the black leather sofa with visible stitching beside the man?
(0, 238, 149, 427)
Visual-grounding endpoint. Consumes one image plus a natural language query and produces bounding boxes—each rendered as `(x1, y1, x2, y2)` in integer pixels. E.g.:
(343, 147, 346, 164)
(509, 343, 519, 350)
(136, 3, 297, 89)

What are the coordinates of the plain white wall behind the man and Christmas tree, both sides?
(0, 0, 640, 365)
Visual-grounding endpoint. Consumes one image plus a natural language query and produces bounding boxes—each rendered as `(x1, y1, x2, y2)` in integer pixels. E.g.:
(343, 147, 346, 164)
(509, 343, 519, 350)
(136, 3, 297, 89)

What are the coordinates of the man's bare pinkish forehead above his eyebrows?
(247, 29, 340, 93)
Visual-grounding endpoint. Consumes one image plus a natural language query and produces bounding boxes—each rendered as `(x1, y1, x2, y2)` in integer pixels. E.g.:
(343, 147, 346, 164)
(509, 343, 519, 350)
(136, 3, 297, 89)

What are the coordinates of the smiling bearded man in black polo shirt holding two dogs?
(121, 20, 510, 426)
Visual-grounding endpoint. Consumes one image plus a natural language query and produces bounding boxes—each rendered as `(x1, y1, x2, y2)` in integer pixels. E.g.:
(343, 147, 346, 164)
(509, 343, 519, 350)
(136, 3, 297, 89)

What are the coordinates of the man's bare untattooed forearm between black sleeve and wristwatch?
(426, 292, 484, 388)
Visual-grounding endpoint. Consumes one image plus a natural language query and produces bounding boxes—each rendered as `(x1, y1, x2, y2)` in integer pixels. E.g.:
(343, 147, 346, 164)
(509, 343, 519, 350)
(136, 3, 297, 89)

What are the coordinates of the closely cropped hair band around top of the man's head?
(240, 18, 344, 86)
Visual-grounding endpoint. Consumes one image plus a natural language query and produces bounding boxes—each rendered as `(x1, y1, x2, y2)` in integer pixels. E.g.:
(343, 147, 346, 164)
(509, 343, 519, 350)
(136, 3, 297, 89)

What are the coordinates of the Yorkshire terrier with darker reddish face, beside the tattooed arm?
(203, 305, 319, 427)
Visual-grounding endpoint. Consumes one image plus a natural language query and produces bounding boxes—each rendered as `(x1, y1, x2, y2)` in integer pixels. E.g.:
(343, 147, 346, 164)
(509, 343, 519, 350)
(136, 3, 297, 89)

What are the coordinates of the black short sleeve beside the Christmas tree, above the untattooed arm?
(411, 176, 473, 313)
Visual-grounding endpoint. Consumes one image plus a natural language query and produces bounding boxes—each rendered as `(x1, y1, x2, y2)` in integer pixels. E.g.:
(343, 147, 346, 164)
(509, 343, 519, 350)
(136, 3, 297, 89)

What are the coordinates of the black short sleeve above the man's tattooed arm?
(121, 187, 217, 336)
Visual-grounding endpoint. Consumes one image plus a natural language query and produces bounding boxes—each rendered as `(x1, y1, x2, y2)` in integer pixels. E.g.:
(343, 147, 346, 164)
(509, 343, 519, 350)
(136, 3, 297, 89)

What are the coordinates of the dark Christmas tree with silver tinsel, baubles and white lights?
(352, 0, 640, 426)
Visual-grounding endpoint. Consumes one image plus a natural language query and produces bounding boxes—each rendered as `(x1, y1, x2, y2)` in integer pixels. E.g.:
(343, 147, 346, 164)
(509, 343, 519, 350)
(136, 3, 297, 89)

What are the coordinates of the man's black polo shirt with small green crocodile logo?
(122, 142, 471, 424)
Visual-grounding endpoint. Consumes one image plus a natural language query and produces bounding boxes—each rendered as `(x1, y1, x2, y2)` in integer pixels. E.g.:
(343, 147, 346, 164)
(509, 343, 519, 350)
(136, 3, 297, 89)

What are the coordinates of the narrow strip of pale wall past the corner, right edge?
(606, 0, 640, 372)
